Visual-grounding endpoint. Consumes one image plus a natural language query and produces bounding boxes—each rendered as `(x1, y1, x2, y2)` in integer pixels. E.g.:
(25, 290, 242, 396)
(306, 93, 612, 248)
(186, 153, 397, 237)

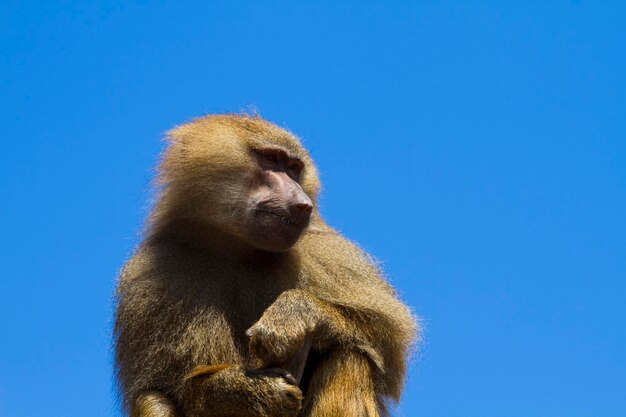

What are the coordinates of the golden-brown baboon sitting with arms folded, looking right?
(114, 115, 418, 417)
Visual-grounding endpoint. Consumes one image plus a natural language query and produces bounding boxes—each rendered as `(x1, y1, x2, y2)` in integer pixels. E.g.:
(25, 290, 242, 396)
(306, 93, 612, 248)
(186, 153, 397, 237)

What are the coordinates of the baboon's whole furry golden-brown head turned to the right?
(161, 116, 319, 252)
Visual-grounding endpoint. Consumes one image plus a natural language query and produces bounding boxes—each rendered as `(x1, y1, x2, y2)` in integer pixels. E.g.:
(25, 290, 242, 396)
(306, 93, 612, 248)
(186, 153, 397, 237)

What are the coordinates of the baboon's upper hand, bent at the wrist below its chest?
(246, 290, 318, 366)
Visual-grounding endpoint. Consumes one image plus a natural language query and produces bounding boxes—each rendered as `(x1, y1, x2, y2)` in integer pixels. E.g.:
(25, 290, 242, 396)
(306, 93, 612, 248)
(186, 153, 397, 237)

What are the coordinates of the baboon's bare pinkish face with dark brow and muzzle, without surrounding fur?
(239, 147, 313, 251)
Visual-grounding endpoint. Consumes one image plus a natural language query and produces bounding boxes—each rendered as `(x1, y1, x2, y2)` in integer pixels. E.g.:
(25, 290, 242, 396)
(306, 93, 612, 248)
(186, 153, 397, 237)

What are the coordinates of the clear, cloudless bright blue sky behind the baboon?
(0, 0, 626, 417)
